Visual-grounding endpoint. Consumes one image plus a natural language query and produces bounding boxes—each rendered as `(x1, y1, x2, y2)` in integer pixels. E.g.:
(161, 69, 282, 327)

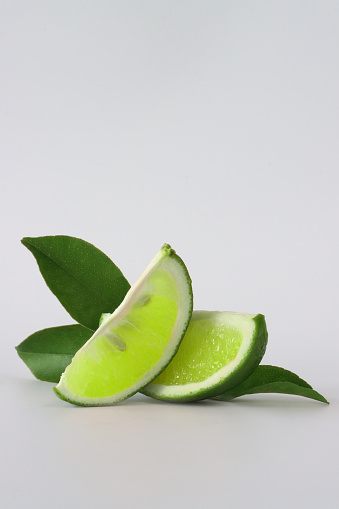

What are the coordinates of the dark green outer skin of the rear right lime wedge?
(140, 314, 268, 402)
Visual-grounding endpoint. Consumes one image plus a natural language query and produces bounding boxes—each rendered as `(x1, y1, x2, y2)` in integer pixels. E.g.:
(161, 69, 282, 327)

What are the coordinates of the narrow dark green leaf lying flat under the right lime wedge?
(213, 366, 328, 403)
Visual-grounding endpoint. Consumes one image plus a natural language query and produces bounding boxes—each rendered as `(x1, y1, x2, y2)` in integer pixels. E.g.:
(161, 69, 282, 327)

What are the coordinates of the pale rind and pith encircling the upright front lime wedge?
(54, 244, 193, 406)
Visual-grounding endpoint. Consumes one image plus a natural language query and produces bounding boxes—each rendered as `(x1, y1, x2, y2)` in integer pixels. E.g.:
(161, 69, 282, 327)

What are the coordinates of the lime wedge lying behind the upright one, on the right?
(141, 311, 267, 401)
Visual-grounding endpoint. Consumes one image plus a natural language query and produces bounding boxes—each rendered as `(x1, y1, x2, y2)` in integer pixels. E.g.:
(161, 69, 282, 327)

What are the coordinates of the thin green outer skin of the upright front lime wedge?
(53, 244, 193, 407)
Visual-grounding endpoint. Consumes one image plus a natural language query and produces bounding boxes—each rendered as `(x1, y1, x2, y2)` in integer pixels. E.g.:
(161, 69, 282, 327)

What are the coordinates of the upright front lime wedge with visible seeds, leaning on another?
(54, 244, 193, 406)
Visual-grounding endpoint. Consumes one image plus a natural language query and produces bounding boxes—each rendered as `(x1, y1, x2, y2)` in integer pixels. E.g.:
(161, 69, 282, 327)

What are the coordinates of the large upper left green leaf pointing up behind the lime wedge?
(21, 235, 130, 330)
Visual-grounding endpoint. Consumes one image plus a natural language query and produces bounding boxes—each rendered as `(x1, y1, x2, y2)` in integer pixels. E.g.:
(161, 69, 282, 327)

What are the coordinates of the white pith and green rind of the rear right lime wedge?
(141, 311, 268, 401)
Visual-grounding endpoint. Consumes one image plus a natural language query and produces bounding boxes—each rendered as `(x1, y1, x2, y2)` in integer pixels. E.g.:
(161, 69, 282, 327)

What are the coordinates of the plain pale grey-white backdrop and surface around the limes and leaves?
(0, 0, 339, 509)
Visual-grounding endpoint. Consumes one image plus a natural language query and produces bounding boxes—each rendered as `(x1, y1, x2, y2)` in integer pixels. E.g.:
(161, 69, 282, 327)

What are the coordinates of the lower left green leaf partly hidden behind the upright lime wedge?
(16, 325, 93, 382)
